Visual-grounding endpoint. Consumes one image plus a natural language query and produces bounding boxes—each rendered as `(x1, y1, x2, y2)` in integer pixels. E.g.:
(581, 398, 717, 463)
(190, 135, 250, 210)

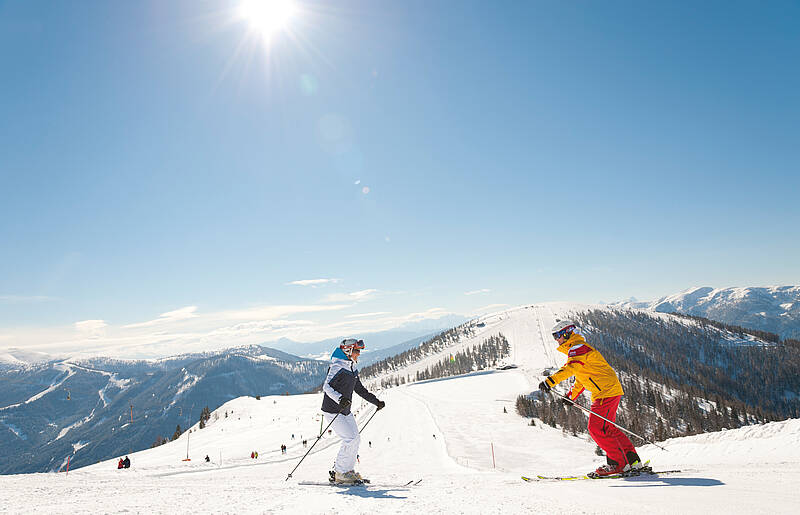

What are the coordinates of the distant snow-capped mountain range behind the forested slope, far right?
(613, 286, 800, 339)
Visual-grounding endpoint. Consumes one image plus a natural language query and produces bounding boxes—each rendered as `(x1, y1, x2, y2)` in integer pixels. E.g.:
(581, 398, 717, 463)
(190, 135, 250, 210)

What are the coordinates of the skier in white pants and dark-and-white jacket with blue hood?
(322, 338, 386, 484)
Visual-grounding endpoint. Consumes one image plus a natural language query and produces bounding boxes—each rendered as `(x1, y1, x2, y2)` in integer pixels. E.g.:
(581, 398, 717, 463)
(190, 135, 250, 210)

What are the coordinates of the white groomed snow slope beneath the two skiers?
(0, 304, 800, 514)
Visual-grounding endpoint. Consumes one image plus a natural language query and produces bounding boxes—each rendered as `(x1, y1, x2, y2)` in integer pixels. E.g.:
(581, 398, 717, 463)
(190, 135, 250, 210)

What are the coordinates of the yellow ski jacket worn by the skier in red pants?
(545, 333, 625, 402)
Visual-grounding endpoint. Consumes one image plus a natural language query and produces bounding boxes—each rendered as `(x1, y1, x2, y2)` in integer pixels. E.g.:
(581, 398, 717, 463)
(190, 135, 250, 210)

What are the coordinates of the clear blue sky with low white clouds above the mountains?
(0, 0, 800, 355)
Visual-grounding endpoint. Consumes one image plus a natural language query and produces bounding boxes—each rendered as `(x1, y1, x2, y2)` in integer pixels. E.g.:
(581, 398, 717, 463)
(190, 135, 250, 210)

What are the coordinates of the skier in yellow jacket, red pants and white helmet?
(539, 320, 642, 477)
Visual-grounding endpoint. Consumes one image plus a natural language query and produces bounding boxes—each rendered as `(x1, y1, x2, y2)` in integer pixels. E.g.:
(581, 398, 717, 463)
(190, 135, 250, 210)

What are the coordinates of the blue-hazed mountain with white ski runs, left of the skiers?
(0, 345, 327, 473)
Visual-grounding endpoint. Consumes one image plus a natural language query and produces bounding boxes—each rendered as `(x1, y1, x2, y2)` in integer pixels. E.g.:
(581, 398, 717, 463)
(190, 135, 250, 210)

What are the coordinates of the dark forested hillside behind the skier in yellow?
(517, 310, 800, 440)
